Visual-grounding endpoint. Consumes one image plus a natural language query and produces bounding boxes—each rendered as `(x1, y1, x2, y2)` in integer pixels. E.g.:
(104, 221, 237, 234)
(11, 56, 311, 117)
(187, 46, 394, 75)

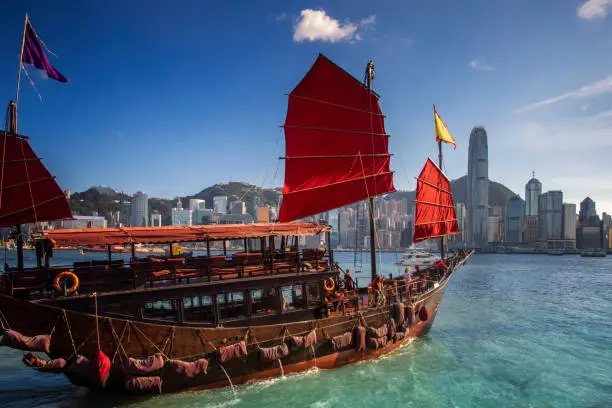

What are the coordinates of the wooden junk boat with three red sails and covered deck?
(0, 55, 471, 393)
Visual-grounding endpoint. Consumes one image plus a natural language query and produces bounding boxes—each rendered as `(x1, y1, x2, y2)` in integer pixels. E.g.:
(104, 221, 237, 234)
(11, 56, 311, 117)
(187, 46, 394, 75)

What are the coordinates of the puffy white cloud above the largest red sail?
(293, 9, 376, 43)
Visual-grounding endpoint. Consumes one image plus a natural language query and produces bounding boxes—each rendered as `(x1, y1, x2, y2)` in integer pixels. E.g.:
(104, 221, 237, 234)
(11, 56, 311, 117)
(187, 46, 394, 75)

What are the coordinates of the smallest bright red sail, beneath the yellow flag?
(414, 159, 459, 242)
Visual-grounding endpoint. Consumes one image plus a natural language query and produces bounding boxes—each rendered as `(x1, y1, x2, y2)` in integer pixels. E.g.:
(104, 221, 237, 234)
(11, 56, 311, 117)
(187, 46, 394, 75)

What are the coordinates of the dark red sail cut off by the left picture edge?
(0, 132, 72, 227)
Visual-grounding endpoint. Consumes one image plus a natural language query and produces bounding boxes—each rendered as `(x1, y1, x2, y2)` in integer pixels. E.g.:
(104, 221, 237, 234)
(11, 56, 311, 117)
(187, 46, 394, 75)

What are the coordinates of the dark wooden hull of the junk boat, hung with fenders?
(0, 250, 469, 392)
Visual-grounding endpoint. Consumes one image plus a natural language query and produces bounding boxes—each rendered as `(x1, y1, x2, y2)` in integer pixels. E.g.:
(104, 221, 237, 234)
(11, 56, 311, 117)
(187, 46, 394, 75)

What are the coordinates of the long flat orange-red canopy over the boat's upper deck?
(44, 222, 331, 246)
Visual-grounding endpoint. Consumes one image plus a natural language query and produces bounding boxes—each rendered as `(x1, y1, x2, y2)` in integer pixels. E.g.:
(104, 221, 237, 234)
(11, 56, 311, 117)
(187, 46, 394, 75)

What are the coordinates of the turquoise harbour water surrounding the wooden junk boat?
(0, 252, 612, 408)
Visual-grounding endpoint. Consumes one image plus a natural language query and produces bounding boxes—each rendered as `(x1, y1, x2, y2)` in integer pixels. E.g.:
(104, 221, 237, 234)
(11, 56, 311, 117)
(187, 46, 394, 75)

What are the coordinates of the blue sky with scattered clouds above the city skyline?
(0, 0, 612, 213)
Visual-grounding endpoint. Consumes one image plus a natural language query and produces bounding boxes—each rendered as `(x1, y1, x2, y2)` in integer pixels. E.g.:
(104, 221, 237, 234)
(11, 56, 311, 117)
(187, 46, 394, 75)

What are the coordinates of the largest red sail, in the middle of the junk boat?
(279, 55, 395, 222)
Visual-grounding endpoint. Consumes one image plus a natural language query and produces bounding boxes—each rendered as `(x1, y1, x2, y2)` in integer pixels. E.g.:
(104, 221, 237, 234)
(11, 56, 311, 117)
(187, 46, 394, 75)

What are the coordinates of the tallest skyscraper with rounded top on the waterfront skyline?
(467, 127, 489, 247)
